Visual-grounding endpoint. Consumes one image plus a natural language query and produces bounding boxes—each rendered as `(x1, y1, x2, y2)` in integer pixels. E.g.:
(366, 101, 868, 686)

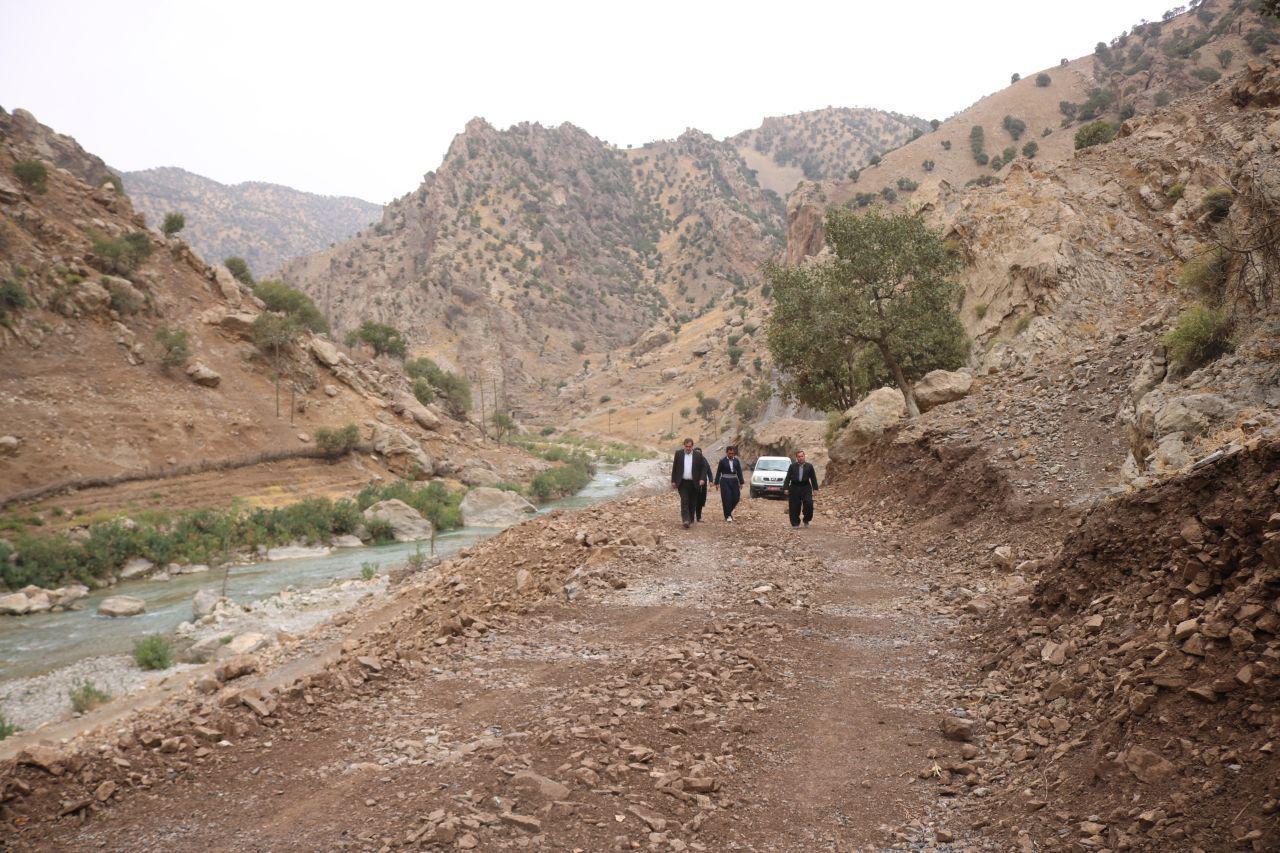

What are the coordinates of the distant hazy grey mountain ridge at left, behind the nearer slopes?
(122, 167, 381, 275)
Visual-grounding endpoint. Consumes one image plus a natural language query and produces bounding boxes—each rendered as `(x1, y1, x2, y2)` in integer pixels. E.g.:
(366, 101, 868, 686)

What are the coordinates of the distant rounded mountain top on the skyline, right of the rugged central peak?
(727, 106, 929, 196)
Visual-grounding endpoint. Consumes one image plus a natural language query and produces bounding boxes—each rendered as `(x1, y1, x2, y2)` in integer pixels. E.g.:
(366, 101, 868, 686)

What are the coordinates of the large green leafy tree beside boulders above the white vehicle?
(767, 209, 969, 418)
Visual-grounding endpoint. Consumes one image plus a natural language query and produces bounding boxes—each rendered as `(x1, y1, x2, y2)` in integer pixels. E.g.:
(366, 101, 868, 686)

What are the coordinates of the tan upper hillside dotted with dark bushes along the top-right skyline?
(788, 0, 1280, 263)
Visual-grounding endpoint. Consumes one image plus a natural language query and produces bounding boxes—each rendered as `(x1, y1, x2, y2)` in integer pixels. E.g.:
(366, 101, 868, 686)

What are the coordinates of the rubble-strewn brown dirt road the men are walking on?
(10, 494, 956, 850)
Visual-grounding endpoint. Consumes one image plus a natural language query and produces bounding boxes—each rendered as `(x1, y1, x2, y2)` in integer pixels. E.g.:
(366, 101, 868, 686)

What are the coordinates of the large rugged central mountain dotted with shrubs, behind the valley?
(275, 119, 783, 399)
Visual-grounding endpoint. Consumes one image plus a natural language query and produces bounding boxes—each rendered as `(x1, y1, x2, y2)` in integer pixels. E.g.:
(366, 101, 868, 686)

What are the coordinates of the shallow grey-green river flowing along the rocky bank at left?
(0, 465, 640, 684)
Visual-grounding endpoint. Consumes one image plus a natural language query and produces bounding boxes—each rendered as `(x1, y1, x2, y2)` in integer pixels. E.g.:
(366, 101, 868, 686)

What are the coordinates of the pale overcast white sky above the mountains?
(0, 0, 1171, 202)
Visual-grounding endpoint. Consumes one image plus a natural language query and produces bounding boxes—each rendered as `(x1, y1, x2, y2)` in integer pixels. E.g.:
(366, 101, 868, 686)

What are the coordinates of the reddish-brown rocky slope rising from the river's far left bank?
(0, 111, 525, 507)
